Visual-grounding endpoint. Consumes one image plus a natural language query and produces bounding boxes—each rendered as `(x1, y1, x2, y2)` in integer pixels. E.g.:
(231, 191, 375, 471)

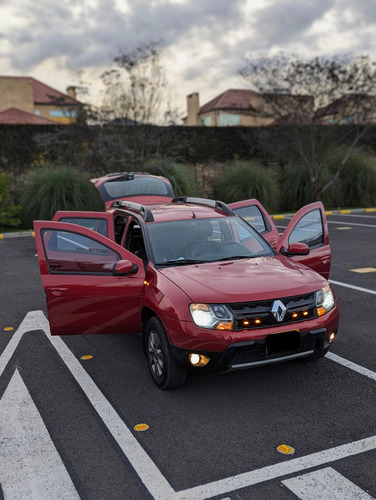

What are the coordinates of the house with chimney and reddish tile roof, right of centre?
(183, 89, 314, 127)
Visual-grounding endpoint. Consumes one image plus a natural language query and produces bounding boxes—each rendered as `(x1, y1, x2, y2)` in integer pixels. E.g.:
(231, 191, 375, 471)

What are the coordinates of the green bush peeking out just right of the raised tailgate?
(145, 159, 201, 196)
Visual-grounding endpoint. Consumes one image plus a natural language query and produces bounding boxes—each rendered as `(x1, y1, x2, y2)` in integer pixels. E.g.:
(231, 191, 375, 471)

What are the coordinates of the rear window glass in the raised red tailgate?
(99, 176, 173, 201)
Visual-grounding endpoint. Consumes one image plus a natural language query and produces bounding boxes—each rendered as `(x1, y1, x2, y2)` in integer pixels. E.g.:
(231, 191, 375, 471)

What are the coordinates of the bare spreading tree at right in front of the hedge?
(239, 54, 376, 201)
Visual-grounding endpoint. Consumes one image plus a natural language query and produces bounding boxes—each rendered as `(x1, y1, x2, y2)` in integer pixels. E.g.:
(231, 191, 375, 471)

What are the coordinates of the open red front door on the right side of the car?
(276, 201, 331, 279)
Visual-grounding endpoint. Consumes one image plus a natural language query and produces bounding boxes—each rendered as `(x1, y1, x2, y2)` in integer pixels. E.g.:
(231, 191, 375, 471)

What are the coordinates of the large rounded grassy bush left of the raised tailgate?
(21, 167, 104, 227)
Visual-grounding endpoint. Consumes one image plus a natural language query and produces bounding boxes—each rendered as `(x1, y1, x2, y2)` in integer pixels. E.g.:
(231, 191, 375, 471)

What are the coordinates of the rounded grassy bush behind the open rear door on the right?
(214, 161, 279, 211)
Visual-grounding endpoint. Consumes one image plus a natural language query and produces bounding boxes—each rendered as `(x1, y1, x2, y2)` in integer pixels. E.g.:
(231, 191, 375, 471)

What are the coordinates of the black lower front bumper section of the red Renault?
(171, 328, 337, 373)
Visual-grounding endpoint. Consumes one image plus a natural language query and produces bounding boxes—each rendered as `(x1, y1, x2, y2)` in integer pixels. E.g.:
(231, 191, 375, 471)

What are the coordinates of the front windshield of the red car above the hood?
(148, 217, 273, 265)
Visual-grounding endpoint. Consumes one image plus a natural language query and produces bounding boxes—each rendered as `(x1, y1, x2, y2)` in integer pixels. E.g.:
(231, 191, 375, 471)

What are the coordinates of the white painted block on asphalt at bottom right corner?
(282, 467, 373, 500)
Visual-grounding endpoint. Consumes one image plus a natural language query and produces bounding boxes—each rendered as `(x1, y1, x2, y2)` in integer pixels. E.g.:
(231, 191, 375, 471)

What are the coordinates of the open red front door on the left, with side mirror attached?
(34, 221, 145, 335)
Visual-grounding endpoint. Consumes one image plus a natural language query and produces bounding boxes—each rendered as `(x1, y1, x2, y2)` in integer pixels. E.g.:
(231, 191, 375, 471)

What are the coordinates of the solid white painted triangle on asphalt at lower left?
(0, 370, 80, 500)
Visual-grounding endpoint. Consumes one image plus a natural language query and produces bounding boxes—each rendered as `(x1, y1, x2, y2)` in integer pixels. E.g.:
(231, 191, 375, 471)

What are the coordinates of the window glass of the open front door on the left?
(42, 229, 120, 274)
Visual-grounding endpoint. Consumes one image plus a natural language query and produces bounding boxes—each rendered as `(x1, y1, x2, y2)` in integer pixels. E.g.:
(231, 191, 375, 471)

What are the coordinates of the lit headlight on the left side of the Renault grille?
(189, 304, 234, 330)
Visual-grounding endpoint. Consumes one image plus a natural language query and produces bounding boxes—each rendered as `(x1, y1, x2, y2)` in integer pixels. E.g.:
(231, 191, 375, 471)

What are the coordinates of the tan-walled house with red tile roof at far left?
(0, 76, 81, 125)
